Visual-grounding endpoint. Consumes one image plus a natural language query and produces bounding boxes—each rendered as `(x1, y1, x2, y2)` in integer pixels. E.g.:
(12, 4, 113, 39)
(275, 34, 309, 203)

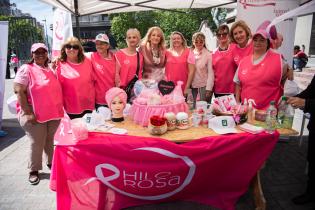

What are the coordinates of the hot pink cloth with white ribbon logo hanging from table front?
(50, 133, 279, 210)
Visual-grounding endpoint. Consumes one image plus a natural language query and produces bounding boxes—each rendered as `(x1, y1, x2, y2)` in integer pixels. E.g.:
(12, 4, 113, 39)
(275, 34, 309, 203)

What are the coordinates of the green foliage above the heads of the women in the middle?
(110, 9, 220, 48)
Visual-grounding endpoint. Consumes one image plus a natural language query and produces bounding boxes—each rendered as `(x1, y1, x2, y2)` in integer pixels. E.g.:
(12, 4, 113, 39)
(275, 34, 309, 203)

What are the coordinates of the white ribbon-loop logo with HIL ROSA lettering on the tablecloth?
(85, 147, 196, 200)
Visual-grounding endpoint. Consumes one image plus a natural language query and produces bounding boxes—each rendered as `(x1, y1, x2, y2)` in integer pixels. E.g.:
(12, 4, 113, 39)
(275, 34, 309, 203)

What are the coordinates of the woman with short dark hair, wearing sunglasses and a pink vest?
(212, 25, 237, 97)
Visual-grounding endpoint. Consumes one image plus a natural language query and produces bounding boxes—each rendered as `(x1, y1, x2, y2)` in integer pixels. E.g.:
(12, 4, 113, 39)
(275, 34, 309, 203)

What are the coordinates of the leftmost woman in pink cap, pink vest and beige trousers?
(14, 43, 64, 185)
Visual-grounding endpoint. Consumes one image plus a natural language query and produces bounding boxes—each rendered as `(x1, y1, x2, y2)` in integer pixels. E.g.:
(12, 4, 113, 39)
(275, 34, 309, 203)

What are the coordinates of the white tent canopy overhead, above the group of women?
(41, 0, 236, 16)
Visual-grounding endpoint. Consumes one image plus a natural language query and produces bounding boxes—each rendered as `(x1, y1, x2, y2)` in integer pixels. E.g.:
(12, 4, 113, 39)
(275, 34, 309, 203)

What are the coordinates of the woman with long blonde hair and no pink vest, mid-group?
(139, 26, 166, 81)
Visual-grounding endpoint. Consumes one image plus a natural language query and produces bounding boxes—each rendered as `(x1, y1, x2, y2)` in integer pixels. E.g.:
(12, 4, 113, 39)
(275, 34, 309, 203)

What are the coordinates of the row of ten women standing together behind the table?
(14, 21, 292, 184)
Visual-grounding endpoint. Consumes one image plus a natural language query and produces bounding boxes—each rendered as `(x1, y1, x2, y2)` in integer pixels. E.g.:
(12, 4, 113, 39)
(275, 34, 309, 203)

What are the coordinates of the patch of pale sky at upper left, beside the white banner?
(10, 0, 53, 36)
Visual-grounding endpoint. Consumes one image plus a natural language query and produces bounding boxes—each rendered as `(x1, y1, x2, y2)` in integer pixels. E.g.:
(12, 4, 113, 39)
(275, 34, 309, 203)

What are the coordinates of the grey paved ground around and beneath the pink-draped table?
(0, 80, 315, 210)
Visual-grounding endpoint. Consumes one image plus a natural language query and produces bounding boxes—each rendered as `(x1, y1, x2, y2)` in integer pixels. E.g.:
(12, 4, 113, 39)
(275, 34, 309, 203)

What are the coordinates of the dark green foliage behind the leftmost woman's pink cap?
(0, 16, 44, 59)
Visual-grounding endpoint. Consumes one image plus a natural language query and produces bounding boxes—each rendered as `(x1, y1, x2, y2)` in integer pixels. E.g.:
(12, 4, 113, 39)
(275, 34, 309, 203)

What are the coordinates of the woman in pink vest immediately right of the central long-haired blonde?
(165, 31, 195, 95)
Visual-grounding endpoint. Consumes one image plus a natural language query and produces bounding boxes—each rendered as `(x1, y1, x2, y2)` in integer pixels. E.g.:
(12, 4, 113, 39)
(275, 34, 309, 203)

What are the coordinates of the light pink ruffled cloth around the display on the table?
(129, 102, 188, 126)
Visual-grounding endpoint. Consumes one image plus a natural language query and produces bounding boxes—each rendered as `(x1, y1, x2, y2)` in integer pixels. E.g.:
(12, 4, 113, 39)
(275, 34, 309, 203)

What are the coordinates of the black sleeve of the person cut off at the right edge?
(296, 75, 315, 131)
